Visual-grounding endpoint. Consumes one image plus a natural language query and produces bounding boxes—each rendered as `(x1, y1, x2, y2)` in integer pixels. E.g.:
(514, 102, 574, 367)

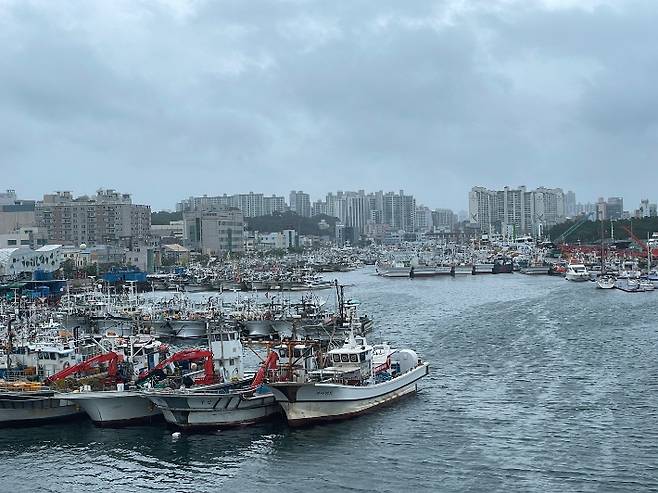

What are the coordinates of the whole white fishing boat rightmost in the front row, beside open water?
(269, 332, 429, 426)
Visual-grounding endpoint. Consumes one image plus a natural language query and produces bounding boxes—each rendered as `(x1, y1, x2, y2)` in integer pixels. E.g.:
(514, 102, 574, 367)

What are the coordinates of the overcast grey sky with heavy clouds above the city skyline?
(0, 0, 658, 210)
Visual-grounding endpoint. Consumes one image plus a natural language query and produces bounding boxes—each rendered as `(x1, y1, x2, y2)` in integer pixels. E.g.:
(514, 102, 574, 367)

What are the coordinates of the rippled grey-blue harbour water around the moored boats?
(0, 269, 658, 493)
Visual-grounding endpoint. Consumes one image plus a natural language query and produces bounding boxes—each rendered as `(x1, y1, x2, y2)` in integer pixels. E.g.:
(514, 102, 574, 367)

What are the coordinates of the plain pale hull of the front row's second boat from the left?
(68, 391, 162, 426)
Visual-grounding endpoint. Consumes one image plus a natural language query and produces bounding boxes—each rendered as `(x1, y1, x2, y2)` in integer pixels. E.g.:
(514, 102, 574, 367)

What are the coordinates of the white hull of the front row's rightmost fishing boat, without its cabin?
(271, 363, 429, 426)
